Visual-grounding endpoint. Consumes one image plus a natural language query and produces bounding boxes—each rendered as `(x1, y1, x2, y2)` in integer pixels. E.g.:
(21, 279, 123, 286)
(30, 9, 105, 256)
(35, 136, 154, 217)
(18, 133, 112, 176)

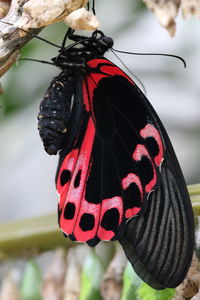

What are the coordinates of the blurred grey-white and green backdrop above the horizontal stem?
(0, 0, 200, 222)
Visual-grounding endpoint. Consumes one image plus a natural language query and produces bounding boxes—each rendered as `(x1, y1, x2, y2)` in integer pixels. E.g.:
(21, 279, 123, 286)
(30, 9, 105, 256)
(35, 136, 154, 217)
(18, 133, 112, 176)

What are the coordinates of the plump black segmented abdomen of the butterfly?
(38, 72, 74, 154)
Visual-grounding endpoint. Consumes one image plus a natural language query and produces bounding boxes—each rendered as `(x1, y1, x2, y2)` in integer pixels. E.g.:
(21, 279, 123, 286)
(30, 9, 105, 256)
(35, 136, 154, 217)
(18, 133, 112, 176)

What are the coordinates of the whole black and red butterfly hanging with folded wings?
(38, 30, 194, 289)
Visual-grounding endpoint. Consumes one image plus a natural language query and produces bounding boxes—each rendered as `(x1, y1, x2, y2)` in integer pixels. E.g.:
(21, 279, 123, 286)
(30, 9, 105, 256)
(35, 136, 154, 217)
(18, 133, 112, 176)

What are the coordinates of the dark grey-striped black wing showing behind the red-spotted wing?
(119, 143, 194, 290)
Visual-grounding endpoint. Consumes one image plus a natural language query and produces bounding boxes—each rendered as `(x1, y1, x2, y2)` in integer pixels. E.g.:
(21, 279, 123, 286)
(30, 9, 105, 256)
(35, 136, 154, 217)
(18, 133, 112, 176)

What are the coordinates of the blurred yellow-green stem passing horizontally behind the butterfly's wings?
(0, 184, 200, 259)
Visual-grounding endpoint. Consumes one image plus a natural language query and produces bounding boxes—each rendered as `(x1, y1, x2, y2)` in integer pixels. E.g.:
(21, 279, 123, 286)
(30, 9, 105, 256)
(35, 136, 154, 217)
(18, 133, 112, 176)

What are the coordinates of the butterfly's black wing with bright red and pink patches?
(58, 59, 168, 245)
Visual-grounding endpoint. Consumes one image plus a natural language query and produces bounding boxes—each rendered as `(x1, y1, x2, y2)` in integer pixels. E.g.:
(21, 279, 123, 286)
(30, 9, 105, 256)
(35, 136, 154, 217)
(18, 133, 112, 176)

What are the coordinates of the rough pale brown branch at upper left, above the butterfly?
(0, 0, 99, 76)
